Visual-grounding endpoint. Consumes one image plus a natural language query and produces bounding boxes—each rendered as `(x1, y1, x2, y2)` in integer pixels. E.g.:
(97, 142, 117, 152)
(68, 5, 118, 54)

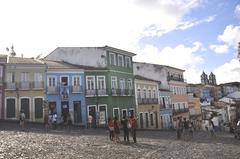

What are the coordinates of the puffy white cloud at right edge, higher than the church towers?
(209, 25, 240, 53)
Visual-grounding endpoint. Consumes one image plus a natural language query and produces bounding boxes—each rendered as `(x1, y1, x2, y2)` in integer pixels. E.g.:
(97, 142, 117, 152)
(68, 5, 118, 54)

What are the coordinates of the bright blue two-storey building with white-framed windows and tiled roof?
(44, 60, 87, 126)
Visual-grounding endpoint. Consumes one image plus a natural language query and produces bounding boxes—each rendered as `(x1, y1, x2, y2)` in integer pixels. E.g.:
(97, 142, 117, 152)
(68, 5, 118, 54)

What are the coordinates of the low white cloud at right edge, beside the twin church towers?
(214, 59, 240, 84)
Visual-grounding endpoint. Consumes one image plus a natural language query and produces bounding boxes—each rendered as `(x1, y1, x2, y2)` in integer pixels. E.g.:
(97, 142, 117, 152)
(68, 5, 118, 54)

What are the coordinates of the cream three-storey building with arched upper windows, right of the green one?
(134, 75, 161, 129)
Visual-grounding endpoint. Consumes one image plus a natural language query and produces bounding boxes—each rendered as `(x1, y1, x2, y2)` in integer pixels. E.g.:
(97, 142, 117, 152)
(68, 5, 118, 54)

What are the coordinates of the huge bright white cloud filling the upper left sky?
(0, 0, 204, 56)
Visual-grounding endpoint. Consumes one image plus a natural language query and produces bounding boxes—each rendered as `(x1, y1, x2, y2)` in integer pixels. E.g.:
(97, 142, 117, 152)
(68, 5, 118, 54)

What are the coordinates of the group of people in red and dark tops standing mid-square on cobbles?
(108, 115, 137, 143)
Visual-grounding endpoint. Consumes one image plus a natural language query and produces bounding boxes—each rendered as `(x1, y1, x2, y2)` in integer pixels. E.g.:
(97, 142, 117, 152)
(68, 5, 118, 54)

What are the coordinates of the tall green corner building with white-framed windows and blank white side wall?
(46, 46, 136, 125)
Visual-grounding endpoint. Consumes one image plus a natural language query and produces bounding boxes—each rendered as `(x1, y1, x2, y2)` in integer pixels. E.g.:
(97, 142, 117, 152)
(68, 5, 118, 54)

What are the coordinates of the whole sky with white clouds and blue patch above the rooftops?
(0, 0, 240, 84)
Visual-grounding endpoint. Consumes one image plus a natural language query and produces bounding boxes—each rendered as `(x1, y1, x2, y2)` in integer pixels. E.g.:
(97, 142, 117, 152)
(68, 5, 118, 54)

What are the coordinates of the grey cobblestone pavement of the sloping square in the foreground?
(0, 123, 240, 159)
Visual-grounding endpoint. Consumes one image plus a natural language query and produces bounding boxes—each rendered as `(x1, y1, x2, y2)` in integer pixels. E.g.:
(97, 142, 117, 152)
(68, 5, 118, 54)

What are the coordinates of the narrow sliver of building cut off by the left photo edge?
(0, 55, 7, 119)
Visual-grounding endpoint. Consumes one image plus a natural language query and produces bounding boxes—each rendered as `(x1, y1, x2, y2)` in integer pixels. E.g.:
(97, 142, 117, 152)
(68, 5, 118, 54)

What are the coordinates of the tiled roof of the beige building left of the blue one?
(8, 57, 43, 65)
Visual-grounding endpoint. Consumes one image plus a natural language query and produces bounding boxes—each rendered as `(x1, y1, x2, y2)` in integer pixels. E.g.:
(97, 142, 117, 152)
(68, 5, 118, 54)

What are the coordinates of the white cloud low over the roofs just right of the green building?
(134, 42, 204, 83)
